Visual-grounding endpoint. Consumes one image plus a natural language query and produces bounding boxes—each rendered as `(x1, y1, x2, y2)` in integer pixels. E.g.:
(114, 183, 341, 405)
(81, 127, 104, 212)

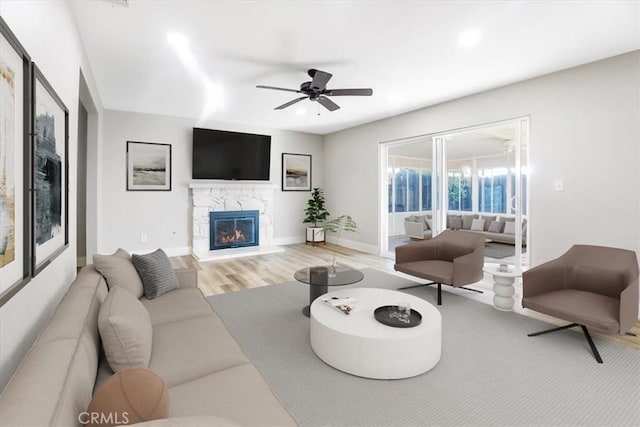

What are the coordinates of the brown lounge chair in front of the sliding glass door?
(394, 230, 484, 305)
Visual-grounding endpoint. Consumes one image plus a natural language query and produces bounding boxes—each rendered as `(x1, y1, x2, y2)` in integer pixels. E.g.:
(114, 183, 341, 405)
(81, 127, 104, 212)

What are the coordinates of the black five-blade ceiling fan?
(256, 68, 373, 111)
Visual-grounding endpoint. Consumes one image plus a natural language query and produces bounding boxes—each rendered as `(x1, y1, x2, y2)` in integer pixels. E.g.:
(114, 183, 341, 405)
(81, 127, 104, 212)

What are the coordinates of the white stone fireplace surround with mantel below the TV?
(189, 181, 283, 261)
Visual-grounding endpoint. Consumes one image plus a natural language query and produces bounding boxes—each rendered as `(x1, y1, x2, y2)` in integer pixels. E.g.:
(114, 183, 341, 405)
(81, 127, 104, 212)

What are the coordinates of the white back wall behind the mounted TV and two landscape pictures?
(98, 110, 323, 255)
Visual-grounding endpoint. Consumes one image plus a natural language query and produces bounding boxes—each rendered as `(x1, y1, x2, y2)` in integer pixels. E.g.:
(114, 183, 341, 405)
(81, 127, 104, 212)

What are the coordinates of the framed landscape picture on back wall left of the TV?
(127, 141, 171, 191)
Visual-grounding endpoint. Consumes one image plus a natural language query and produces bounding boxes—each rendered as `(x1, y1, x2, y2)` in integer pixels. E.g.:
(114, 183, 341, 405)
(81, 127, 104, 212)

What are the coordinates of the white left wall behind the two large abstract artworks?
(0, 0, 104, 389)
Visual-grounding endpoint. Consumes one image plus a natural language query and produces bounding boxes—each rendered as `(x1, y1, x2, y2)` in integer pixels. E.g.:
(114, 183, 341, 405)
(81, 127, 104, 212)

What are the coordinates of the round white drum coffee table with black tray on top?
(310, 288, 442, 379)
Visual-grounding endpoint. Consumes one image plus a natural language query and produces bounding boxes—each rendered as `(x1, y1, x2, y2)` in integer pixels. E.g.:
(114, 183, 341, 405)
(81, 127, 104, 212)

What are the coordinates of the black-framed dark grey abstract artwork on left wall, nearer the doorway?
(31, 64, 69, 277)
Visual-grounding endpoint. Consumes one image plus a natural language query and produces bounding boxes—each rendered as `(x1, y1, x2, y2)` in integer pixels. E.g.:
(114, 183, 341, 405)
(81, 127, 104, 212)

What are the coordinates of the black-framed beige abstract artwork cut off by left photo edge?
(0, 18, 31, 307)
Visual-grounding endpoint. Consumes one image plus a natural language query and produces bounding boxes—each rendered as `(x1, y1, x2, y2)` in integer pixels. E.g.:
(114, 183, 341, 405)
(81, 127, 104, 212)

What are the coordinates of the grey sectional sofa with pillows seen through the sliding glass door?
(404, 214, 527, 245)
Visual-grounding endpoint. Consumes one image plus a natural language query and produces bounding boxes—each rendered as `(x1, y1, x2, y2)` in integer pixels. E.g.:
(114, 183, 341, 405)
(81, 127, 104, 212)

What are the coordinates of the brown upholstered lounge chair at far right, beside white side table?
(522, 245, 638, 363)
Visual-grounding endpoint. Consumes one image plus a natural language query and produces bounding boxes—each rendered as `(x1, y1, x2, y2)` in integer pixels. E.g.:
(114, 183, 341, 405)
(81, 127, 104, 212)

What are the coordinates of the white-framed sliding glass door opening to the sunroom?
(380, 118, 529, 268)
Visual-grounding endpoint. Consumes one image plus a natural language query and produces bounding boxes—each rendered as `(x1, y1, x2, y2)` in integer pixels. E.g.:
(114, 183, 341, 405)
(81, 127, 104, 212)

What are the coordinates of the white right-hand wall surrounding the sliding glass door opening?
(324, 51, 640, 265)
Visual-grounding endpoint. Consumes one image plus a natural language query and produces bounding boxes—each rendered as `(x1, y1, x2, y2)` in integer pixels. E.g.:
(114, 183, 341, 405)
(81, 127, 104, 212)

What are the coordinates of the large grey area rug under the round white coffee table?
(209, 269, 640, 427)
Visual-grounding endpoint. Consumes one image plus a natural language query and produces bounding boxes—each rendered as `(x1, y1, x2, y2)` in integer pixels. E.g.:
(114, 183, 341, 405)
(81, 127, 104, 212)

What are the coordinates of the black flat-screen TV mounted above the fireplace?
(191, 128, 271, 181)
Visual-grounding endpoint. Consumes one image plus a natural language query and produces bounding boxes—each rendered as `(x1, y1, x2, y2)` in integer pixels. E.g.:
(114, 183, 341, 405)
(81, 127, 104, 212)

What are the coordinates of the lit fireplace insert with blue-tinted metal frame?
(209, 210, 260, 251)
